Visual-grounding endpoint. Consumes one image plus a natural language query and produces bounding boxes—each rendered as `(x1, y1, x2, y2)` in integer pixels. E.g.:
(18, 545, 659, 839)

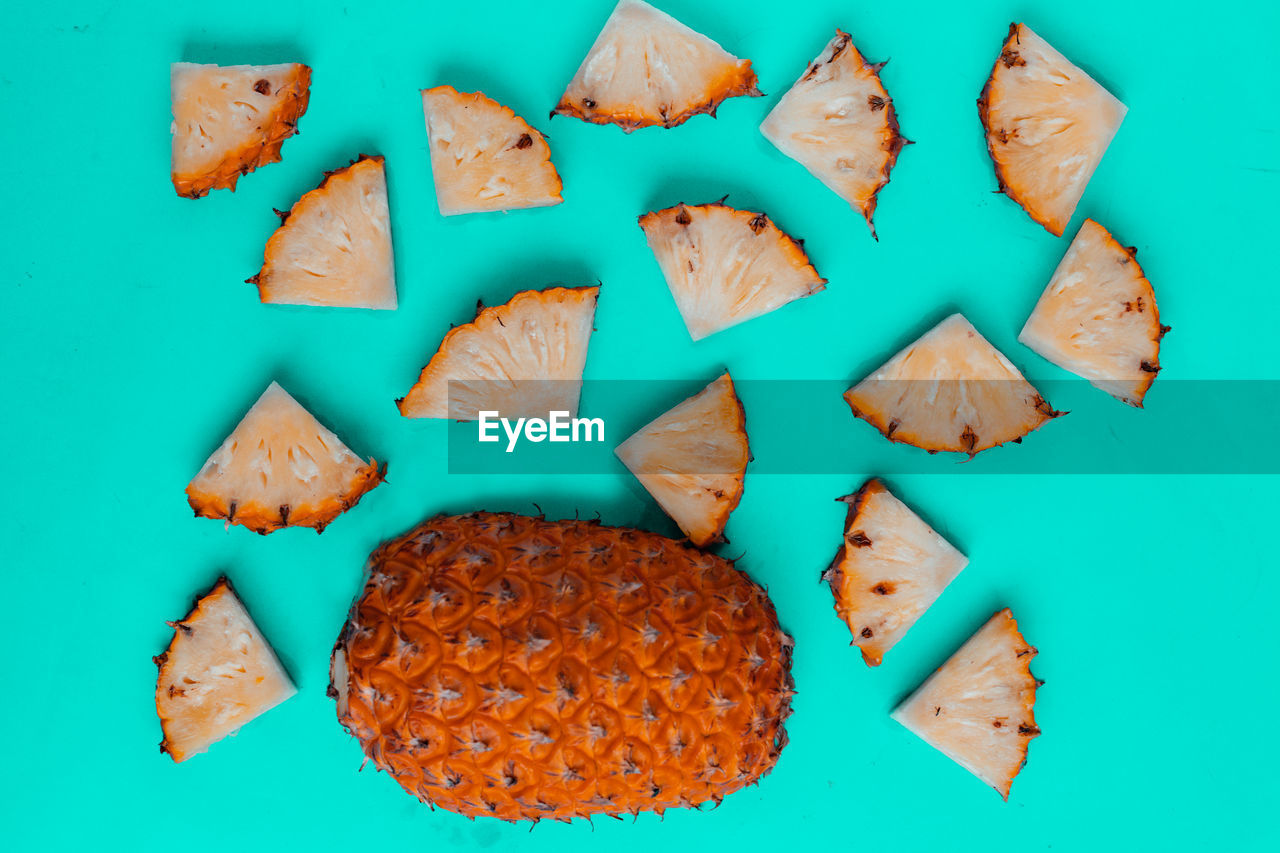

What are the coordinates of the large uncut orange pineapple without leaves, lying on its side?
(330, 512, 792, 821)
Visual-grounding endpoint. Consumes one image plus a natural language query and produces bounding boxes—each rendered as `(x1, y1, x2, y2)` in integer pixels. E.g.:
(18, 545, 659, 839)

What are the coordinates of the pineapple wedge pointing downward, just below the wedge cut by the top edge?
(640, 202, 827, 341)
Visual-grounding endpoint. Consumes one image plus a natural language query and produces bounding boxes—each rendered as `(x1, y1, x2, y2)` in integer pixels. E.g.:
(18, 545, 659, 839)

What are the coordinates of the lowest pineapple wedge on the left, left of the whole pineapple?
(155, 578, 297, 761)
